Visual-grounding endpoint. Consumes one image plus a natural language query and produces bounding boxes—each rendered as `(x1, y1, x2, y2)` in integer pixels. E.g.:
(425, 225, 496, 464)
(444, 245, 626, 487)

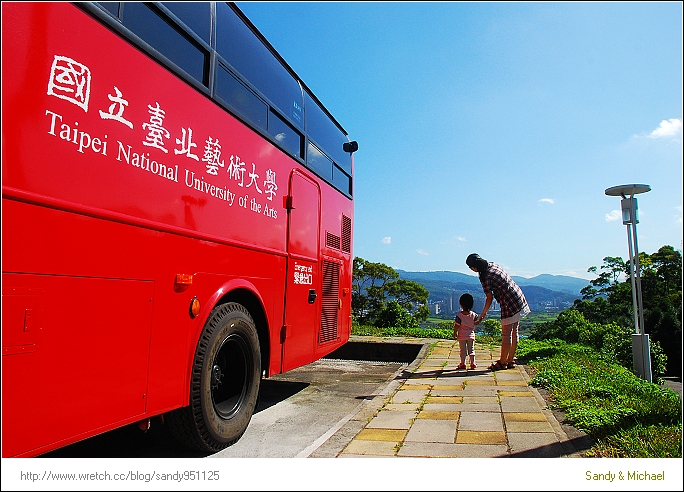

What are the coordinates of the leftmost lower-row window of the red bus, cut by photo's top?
(122, 2, 209, 86)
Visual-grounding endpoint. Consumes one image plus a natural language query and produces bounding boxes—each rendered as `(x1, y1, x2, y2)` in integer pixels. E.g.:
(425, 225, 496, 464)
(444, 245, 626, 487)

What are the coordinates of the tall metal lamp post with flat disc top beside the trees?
(605, 184, 652, 383)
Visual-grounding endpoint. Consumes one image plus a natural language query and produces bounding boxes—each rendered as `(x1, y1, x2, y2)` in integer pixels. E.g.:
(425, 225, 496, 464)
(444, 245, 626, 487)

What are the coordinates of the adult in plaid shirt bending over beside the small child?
(466, 253, 530, 371)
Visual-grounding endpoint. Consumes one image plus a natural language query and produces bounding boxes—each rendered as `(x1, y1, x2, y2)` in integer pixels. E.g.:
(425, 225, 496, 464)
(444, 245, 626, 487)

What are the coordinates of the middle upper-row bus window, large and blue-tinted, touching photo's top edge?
(216, 2, 304, 129)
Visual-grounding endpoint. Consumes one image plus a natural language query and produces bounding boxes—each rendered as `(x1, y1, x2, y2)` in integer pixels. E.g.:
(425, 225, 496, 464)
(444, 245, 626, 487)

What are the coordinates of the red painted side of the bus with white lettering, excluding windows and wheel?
(2, 3, 353, 456)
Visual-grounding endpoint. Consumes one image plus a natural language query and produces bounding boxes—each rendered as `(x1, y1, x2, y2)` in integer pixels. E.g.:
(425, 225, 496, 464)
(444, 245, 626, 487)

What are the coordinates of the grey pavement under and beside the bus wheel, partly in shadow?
(43, 359, 407, 458)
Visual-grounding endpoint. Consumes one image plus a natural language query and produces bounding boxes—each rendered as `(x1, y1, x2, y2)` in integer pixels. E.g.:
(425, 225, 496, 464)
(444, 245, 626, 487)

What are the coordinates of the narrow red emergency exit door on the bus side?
(281, 170, 321, 372)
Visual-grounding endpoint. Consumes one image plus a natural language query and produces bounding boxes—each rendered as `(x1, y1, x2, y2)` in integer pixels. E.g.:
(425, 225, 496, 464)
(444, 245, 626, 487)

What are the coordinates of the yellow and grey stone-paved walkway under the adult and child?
(337, 337, 579, 458)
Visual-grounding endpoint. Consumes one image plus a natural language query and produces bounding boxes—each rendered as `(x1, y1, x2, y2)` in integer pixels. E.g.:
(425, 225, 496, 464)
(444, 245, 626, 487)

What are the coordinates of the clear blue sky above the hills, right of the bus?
(238, 2, 682, 279)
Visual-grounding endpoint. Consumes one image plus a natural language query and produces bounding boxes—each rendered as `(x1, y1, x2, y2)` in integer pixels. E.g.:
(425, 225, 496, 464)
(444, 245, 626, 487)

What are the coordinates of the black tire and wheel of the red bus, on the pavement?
(168, 302, 261, 453)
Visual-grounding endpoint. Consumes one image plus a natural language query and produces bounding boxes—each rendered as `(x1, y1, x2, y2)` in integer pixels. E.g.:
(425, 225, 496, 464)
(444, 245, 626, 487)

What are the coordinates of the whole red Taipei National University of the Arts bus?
(2, 2, 358, 457)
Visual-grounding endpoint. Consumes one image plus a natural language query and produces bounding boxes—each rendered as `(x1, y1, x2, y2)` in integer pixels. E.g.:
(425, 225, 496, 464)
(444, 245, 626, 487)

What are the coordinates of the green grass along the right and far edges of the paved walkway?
(352, 326, 682, 458)
